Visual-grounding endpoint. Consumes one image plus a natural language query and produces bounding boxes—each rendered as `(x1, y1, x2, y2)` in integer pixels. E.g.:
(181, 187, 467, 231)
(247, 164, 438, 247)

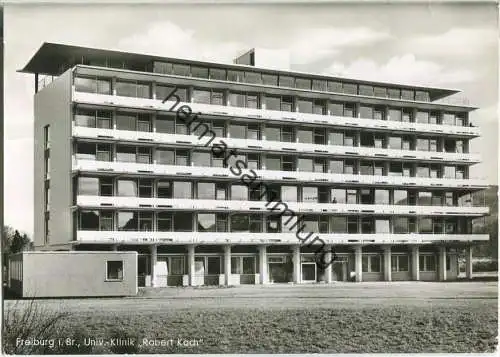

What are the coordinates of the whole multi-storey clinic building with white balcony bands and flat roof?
(22, 43, 489, 287)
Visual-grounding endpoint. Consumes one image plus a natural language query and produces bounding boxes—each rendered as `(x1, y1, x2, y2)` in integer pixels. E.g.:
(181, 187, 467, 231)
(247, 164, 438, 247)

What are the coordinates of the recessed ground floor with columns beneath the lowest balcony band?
(75, 244, 472, 287)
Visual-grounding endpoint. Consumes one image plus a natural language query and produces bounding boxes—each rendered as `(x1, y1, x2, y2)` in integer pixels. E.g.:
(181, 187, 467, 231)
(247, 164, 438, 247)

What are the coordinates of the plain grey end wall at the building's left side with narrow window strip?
(34, 70, 72, 248)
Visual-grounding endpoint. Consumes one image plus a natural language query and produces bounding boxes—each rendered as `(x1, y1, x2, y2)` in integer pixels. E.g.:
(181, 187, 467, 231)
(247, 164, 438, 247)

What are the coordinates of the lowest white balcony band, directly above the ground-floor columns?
(76, 231, 489, 248)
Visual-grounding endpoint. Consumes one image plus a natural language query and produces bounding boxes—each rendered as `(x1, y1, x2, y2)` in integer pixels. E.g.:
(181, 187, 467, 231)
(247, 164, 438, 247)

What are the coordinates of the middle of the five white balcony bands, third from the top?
(73, 158, 488, 189)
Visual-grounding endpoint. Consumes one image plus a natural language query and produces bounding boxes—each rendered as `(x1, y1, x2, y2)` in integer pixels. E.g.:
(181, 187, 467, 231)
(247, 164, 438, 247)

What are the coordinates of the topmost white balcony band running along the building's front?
(72, 90, 481, 137)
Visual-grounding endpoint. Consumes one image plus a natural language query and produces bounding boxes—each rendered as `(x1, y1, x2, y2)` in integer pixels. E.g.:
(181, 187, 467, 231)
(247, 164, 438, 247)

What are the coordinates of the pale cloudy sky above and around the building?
(4, 2, 498, 236)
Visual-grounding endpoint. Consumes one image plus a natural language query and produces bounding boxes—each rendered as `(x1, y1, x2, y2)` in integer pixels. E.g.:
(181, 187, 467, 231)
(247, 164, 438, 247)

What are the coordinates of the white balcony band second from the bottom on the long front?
(77, 195, 489, 217)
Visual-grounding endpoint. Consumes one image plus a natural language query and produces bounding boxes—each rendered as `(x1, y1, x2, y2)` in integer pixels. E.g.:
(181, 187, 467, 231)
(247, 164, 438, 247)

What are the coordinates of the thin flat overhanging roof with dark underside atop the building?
(22, 42, 460, 101)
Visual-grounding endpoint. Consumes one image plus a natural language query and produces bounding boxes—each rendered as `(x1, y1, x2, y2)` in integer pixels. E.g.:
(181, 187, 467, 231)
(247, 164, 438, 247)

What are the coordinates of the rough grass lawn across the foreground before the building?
(3, 284, 498, 353)
